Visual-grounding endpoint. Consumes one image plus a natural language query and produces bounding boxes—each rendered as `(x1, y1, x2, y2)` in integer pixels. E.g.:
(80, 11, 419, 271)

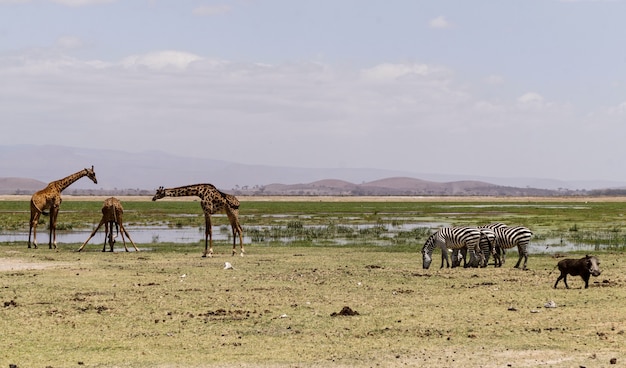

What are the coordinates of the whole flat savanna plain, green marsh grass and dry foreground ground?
(0, 196, 626, 368)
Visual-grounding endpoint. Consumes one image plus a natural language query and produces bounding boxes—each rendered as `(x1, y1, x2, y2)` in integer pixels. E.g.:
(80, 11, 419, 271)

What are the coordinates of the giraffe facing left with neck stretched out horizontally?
(152, 184, 244, 257)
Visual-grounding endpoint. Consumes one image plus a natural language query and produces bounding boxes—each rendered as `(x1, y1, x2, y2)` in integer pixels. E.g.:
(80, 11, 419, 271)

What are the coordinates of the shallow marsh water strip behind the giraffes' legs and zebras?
(0, 222, 610, 254)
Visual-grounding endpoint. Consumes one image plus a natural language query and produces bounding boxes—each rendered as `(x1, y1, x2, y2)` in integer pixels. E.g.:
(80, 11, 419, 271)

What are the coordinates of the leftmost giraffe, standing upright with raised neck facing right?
(28, 165, 98, 249)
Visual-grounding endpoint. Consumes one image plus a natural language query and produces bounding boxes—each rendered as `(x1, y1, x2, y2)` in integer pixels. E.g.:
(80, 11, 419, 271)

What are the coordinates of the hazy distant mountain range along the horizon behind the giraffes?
(0, 145, 626, 196)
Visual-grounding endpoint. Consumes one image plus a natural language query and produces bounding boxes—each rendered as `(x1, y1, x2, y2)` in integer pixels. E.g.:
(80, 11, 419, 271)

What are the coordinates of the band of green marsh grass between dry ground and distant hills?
(6, 198, 626, 248)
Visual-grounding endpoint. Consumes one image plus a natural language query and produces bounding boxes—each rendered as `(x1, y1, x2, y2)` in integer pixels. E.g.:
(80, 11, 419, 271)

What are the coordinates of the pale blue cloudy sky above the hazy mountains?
(0, 0, 626, 181)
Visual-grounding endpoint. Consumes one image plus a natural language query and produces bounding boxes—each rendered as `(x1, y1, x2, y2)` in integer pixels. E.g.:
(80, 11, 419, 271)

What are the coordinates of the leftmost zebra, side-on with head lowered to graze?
(422, 226, 484, 269)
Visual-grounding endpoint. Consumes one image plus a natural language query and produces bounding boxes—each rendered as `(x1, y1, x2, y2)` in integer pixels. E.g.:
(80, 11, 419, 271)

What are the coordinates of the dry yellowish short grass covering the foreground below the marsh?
(0, 245, 626, 367)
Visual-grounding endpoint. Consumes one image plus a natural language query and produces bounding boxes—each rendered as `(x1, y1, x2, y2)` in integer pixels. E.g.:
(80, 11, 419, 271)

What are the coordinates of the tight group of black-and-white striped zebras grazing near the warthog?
(422, 222, 532, 269)
